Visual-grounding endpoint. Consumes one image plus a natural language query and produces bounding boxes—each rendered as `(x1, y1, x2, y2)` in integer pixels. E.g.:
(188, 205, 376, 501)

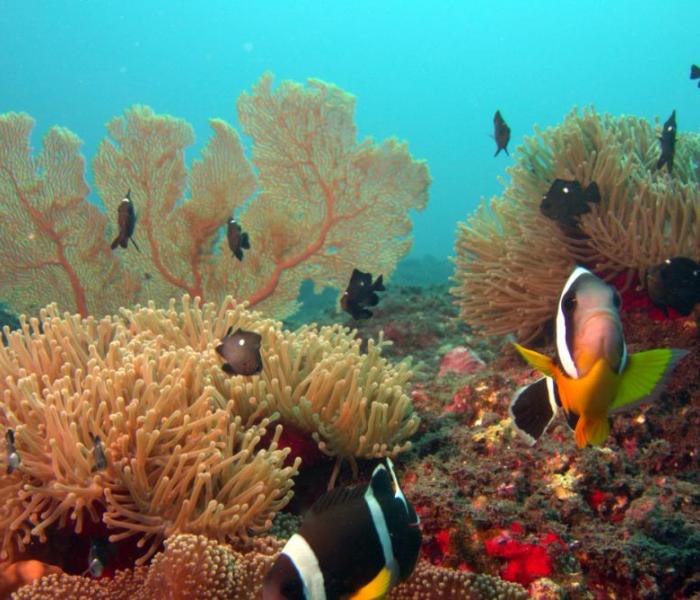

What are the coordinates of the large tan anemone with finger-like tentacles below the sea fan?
(0, 296, 418, 568)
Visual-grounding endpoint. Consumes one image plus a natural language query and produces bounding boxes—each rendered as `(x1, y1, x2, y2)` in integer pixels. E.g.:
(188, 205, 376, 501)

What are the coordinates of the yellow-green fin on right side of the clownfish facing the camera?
(610, 348, 688, 412)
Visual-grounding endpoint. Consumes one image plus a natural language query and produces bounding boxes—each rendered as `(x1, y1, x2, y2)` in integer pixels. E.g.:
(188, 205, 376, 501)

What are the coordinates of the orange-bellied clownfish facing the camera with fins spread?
(510, 267, 688, 448)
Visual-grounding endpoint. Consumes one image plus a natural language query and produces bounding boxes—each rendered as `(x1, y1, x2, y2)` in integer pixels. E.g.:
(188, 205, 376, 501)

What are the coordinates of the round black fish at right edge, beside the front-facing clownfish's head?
(646, 256, 700, 316)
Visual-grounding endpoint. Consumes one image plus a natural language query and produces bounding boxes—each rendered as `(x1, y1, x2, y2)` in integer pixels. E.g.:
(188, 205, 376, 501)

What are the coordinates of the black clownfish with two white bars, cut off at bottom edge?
(263, 459, 421, 600)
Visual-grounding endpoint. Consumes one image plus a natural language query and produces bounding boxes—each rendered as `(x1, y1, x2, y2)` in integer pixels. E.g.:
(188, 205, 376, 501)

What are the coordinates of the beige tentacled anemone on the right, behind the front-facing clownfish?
(452, 110, 700, 341)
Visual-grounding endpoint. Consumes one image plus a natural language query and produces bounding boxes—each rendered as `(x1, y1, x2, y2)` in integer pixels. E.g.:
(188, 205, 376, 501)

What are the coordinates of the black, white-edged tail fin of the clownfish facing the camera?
(508, 377, 557, 446)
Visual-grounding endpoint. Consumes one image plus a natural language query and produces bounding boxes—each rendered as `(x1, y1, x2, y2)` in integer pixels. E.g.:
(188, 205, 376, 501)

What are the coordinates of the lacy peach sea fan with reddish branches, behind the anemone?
(0, 74, 430, 318)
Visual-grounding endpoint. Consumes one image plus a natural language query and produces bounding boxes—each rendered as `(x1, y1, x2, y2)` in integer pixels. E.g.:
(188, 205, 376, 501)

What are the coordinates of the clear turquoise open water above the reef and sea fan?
(0, 0, 700, 257)
